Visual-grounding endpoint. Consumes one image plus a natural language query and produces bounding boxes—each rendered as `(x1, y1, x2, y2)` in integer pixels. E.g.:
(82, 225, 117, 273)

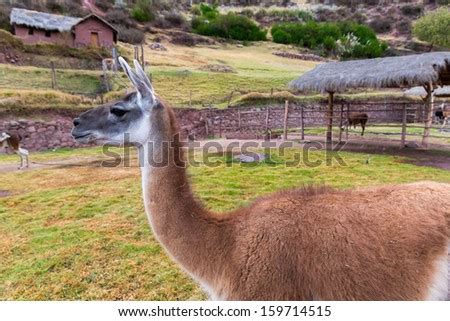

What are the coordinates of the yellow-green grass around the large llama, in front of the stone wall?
(0, 148, 450, 300)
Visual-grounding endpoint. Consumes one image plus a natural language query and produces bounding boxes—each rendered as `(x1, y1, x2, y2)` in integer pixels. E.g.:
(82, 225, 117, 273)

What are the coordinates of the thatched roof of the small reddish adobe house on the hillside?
(10, 8, 81, 32)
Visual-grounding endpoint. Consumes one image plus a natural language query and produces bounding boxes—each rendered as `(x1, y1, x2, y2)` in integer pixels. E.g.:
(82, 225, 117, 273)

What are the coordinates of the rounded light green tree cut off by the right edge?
(413, 7, 450, 50)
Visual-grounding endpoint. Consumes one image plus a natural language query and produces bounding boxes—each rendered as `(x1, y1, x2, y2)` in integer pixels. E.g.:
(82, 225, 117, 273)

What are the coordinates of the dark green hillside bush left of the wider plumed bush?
(192, 10, 266, 41)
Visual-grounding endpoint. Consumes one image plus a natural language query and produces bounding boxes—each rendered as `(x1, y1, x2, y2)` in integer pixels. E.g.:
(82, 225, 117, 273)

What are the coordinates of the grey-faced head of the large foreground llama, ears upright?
(72, 57, 163, 145)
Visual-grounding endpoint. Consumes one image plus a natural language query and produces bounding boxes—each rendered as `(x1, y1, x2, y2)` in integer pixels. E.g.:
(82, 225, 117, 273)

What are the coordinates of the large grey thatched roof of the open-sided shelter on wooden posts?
(290, 52, 450, 92)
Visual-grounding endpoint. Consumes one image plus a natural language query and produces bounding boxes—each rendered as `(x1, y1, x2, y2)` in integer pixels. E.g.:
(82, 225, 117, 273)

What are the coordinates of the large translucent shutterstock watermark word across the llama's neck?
(101, 133, 347, 167)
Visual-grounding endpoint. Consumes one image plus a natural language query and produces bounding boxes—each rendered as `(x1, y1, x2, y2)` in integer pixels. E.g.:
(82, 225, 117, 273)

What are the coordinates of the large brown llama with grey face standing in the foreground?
(72, 59, 450, 300)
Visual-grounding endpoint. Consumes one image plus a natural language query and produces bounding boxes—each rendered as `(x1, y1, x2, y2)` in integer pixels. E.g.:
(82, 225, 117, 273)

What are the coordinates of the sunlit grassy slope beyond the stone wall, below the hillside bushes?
(0, 38, 412, 109)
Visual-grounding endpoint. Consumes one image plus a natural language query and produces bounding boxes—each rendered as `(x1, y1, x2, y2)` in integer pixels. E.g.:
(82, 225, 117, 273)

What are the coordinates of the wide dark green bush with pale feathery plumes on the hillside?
(272, 21, 387, 59)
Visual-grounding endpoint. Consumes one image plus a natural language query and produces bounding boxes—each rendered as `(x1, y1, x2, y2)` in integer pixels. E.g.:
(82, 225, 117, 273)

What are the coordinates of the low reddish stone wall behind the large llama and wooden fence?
(0, 102, 422, 152)
